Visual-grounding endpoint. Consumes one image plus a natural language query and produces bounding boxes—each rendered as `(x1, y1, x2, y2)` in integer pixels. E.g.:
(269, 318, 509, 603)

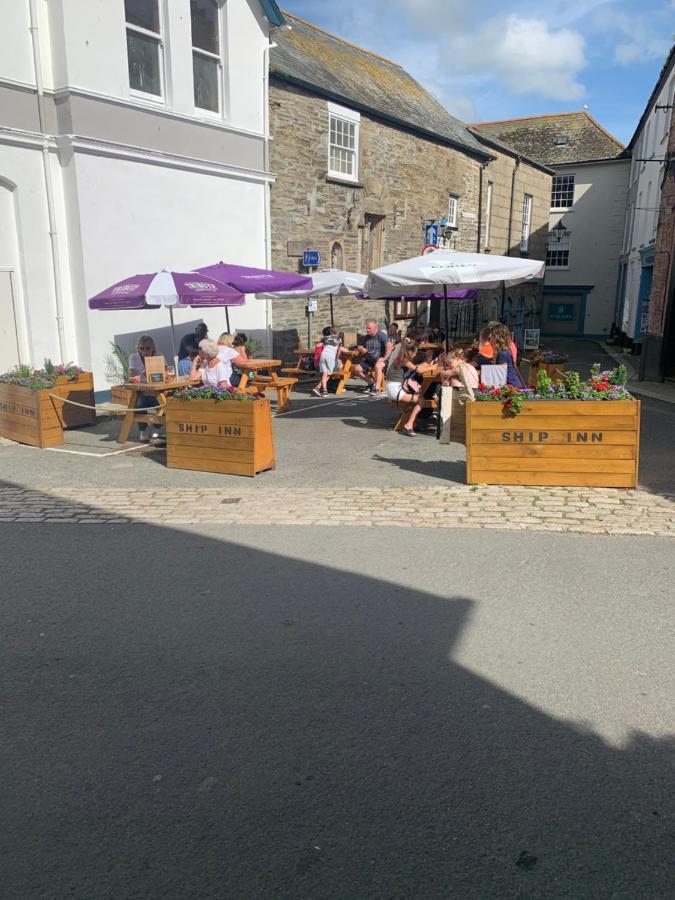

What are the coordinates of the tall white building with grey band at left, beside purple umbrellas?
(0, 0, 283, 390)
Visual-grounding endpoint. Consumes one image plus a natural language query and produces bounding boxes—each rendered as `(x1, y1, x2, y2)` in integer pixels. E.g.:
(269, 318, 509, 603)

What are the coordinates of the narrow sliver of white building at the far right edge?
(615, 50, 675, 347)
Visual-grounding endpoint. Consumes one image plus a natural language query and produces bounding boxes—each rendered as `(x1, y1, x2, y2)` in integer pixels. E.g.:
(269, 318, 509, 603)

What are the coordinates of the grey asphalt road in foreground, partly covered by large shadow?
(0, 511, 675, 900)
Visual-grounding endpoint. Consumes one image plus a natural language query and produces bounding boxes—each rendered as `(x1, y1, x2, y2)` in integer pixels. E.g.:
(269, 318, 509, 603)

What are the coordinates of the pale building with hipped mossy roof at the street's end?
(474, 111, 630, 335)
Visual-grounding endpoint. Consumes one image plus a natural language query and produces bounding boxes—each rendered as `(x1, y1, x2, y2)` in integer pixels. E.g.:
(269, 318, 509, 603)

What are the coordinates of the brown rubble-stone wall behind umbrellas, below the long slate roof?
(270, 77, 551, 360)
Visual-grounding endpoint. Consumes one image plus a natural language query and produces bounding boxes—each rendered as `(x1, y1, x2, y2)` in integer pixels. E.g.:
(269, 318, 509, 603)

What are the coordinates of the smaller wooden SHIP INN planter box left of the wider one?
(166, 397, 275, 475)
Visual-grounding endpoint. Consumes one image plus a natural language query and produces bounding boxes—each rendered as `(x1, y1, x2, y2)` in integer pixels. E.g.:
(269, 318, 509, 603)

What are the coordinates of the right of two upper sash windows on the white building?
(190, 0, 222, 113)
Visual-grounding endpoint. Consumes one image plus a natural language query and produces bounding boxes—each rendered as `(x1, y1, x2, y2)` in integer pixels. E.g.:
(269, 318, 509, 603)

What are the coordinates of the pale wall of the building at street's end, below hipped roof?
(546, 160, 630, 334)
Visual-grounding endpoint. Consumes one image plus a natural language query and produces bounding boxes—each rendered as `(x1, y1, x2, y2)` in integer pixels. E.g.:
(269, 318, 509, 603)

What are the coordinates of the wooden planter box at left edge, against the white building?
(0, 372, 96, 447)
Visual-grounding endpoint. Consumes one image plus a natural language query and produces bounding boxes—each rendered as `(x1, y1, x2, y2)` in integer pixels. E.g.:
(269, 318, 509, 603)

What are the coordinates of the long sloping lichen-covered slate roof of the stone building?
(270, 10, 491, 159)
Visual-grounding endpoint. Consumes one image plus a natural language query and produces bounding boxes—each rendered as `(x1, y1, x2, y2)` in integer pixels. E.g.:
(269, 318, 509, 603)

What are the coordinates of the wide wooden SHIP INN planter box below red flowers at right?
(466, 400, 640, 488)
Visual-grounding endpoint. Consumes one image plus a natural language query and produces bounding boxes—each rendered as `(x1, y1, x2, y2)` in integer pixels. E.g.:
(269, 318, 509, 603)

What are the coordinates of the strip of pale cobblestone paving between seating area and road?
(0, 485, 675, 537)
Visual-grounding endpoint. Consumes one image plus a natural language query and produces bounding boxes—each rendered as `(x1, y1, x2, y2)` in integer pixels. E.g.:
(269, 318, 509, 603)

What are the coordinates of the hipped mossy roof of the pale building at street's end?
(471, 110, 626, 168)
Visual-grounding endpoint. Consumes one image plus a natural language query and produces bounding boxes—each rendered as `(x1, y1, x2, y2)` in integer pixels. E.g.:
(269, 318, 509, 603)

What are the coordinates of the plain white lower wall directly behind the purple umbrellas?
(71, 153, 266, 390)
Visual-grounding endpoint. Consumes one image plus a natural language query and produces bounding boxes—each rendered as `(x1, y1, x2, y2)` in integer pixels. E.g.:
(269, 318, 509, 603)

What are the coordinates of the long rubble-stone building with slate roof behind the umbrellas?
(269, 15, 551, 356)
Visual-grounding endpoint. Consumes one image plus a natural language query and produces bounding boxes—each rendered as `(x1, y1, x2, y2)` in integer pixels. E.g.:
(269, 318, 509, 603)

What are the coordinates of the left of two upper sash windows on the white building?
(124, 0, 164, 97)
